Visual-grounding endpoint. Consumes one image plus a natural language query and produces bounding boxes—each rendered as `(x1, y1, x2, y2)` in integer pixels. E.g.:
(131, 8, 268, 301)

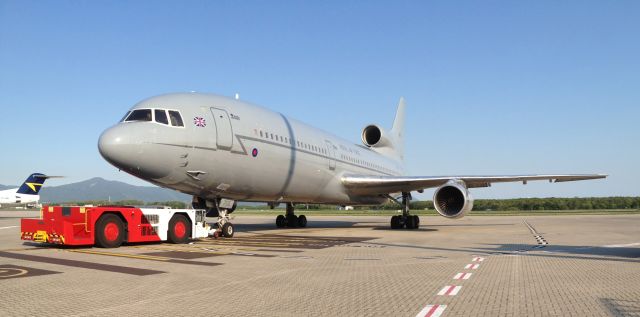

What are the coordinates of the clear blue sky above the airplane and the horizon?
(0, 0, 640, 198)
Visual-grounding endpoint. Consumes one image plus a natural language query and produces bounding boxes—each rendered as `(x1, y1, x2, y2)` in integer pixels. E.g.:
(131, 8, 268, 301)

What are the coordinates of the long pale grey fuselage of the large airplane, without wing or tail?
(99, 93, 404, 205)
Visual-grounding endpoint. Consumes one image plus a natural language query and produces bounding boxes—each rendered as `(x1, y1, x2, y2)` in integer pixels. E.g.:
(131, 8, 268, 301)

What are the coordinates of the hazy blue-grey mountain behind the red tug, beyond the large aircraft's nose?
(40, 177, 191, 203)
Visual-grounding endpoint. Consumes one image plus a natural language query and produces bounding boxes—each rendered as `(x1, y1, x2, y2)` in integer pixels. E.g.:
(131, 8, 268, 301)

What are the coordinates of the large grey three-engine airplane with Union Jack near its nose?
(98, 92, 607, 237)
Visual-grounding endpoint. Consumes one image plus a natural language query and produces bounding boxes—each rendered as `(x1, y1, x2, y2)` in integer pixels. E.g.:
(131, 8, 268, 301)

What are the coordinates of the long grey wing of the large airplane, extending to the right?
(342, 174, 607, 195)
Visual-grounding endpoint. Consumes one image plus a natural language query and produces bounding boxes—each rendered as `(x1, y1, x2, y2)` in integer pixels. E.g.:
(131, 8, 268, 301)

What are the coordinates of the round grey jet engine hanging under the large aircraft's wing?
(433, 181, 473, 218)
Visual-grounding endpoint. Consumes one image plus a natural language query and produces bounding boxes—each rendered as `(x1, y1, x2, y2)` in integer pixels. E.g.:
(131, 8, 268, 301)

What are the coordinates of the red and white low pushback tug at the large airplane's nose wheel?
(20, 206, 212, 248)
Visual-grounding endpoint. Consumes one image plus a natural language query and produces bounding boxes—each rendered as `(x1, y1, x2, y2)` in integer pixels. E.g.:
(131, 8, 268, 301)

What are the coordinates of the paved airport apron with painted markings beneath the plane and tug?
(0, 211, 640, 317)
